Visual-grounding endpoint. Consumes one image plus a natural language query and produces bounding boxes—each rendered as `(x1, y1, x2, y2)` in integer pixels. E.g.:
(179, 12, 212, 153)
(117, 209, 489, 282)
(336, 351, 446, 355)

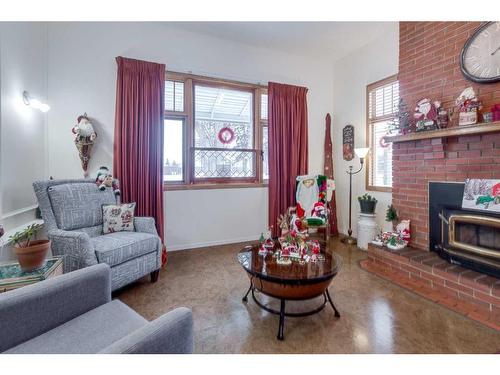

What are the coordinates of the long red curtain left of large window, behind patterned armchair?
(113, 57, 165, 240)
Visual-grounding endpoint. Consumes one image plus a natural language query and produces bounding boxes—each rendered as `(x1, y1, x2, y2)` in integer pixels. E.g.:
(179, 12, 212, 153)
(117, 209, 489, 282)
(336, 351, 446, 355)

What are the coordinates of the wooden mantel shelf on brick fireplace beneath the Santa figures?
(385, 121, 500, 143)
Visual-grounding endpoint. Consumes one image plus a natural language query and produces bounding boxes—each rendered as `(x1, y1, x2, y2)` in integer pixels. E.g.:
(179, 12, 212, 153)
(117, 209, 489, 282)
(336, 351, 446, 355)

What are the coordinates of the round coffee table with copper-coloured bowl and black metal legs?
(238, 245, 342, 340)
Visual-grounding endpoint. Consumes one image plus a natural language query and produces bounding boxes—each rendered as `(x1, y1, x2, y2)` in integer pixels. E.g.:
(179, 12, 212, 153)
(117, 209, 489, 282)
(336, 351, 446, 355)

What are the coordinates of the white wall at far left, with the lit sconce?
(0, 22, 48, 260)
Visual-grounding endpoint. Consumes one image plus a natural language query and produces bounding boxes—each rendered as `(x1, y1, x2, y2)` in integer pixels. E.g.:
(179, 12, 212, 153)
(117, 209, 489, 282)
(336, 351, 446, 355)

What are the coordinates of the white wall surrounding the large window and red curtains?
(48, 23, 333, 250)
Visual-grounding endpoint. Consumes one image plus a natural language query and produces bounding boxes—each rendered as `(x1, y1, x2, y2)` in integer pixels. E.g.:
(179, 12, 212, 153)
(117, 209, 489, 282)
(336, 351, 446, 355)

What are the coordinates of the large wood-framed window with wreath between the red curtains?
(164, 72, 268, 189)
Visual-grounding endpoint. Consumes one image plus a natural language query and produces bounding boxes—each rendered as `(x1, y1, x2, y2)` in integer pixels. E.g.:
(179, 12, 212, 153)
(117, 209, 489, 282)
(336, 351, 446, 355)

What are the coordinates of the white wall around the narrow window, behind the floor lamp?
(332, 22, 399, 235)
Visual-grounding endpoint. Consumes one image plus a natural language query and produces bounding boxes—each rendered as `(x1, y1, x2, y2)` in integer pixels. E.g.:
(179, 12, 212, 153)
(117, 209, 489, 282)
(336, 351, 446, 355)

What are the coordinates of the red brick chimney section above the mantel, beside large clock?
(398, 22, 500, 113)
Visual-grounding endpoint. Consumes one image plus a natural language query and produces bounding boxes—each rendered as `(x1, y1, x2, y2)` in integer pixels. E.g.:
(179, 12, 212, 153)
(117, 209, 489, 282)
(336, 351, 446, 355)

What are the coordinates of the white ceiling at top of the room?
(172, 22, 396, 61)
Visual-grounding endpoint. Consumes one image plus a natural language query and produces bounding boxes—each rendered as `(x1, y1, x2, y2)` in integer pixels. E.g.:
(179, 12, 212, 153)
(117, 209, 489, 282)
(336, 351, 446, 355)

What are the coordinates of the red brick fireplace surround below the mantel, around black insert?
(392, 133, 500, 250)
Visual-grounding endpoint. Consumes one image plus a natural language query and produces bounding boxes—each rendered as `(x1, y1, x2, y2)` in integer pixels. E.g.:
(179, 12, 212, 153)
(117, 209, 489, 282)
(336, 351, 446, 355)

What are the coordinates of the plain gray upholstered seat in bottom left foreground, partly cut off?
(0, 264, 194, 354)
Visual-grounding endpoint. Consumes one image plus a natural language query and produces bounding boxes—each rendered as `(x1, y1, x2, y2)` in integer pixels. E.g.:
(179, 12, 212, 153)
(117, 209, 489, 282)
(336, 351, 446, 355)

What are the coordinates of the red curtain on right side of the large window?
(268, 82, 308, 236)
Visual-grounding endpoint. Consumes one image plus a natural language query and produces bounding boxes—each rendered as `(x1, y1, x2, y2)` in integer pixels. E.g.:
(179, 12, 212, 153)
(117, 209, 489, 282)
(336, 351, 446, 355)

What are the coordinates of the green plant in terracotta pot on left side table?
(9, 224, 50, 272)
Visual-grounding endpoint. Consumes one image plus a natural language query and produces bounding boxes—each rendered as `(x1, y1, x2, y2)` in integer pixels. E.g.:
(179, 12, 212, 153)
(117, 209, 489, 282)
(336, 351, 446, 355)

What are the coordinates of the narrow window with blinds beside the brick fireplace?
(366, 76, 399, 191)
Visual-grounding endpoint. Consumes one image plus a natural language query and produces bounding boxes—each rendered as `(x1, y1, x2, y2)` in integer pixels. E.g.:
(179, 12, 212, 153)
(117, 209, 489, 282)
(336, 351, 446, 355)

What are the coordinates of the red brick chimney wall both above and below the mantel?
(392, 22, 500, 250)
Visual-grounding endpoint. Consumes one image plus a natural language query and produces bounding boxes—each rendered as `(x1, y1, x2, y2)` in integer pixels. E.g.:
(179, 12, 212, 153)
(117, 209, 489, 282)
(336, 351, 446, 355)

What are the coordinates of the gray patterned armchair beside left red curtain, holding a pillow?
(33, 179, 162, 290)
